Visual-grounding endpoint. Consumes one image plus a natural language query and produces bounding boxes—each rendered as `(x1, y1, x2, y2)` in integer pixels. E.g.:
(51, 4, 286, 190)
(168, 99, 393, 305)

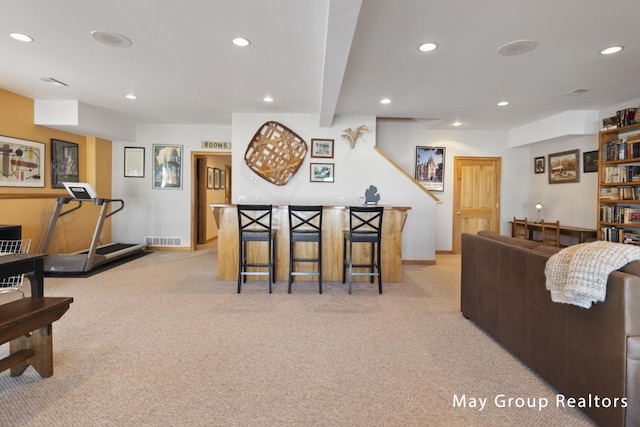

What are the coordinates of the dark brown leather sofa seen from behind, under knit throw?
(461, 231, 640, 427)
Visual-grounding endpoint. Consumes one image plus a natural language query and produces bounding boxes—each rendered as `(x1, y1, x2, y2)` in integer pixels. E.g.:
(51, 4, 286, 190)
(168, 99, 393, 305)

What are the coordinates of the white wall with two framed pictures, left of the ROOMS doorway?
(112, 125, 231, 247)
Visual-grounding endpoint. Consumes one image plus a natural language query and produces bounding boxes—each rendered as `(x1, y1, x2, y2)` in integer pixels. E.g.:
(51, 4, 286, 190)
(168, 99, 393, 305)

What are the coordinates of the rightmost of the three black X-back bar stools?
(342, 206, 384, 293)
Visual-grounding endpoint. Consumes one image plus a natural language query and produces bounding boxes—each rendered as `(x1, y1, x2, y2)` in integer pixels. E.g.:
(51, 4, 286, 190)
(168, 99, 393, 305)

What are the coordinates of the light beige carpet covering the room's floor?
(0, 249, 592, 426)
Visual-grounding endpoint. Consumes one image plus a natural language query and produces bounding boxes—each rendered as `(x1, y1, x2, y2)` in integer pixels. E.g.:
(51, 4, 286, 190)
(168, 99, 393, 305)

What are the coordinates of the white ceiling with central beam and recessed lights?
(0, 0, 640, 135)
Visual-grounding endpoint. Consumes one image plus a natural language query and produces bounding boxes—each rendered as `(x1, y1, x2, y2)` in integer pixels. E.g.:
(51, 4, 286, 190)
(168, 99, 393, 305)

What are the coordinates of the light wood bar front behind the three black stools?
(210, 204, 411, 284)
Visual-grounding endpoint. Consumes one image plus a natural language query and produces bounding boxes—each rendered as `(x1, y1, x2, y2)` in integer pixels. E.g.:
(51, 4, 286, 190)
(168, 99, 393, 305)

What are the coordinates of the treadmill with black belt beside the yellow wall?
(39, 182, 147, 276)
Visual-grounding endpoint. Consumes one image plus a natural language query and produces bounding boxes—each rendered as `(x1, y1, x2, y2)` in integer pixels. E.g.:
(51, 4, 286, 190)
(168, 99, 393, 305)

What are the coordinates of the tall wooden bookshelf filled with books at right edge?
(598, 123, 640, 245)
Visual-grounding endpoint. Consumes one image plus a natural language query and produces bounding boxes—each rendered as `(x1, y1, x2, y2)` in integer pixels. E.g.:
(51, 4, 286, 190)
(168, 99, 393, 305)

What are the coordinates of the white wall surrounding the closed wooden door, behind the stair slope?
(378, 119, 535, 251)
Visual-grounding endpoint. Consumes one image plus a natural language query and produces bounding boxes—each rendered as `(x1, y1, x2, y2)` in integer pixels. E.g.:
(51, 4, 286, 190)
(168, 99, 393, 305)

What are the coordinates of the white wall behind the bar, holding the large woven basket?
(232, 114, 436, 260)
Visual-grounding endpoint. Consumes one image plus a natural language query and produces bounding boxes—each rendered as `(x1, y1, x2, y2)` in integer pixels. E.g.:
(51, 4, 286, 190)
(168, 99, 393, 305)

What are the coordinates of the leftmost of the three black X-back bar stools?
(237, 205, 276, 293)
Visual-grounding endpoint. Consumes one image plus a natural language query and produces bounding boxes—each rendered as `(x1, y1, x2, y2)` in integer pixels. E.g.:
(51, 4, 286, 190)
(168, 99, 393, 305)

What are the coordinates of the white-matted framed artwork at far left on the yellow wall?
(0, 136, 45, 187)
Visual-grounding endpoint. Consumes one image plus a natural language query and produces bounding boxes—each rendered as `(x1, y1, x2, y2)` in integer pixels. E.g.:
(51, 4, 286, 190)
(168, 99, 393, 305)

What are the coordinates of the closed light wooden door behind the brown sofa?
(452, 157, 502, 254)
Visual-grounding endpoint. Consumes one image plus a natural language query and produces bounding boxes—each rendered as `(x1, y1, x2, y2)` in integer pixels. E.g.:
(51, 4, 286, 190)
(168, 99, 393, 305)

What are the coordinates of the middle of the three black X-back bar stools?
(288, 205, 322, 293)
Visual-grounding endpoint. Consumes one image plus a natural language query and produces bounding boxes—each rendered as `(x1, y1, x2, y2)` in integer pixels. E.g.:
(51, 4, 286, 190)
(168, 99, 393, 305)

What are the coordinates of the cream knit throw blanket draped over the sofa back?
(544, 241, 640, 308)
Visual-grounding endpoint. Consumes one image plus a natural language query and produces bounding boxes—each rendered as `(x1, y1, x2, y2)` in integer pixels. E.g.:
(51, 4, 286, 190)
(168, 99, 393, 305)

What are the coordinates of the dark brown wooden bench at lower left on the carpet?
(0, 297, 73, 378)
